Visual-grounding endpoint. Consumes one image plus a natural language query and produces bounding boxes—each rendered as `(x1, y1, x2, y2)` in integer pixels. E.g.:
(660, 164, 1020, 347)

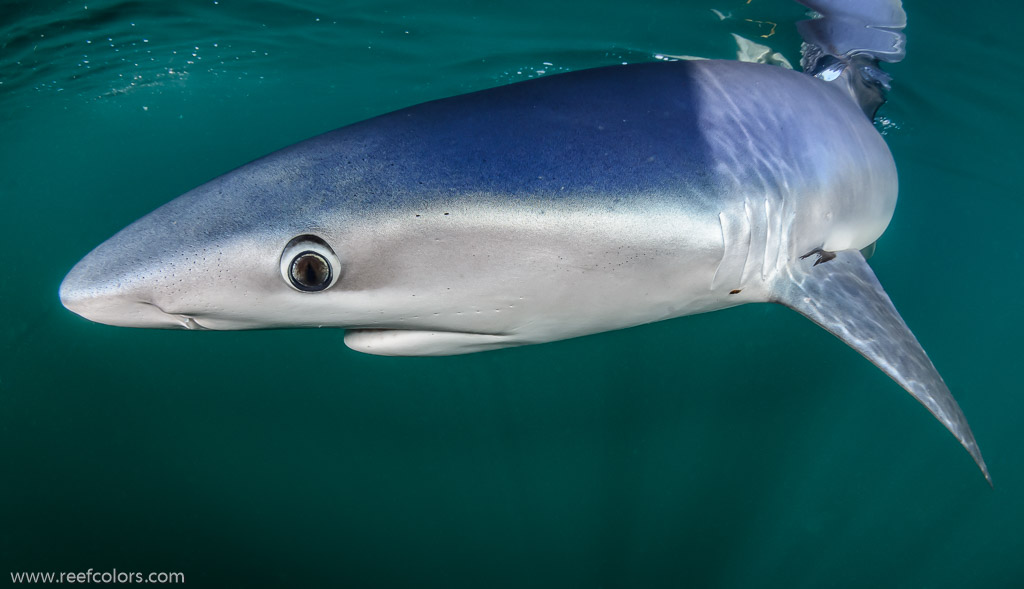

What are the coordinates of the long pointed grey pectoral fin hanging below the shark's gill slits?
(772, 251, 992, 485)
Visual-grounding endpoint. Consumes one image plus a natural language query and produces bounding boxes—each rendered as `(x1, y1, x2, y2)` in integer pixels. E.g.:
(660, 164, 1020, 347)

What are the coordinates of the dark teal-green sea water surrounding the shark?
(0, 0, 1024, 588)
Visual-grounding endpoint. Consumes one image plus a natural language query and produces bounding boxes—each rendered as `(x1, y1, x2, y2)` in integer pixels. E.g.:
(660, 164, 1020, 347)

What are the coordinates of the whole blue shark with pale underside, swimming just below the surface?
(60, 0, 988, 478)
